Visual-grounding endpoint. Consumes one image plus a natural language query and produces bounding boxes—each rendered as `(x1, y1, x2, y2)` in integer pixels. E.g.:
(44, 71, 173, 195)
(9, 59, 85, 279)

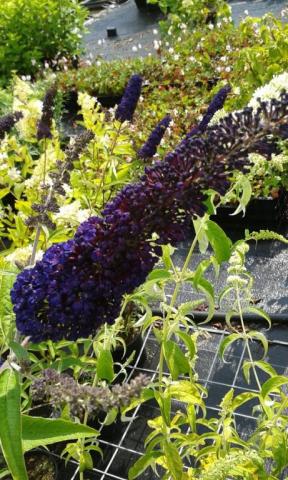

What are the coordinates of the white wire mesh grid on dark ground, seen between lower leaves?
(51, 318, 288, 480)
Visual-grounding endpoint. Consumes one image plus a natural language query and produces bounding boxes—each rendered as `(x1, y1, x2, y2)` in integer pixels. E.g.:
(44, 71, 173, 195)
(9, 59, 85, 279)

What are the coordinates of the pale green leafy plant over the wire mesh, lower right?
(127, 226, 288, 480)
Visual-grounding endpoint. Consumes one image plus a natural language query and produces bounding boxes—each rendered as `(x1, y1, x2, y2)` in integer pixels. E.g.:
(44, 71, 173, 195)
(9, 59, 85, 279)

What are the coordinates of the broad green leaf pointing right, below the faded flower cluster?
(22, 415, 99, 452)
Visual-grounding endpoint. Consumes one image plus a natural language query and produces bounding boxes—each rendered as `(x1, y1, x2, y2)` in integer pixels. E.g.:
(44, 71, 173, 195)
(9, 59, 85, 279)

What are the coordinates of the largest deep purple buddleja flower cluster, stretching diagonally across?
(12, 92, 288, 341)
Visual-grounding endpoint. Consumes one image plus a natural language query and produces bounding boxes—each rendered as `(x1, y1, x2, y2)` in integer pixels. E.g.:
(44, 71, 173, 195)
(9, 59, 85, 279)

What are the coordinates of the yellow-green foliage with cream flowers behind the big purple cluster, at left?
(0, 85, 143, 255)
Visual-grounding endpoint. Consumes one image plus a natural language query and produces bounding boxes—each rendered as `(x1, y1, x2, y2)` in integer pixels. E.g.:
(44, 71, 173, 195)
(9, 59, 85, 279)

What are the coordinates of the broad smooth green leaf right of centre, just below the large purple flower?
(205, 220, 232, 264)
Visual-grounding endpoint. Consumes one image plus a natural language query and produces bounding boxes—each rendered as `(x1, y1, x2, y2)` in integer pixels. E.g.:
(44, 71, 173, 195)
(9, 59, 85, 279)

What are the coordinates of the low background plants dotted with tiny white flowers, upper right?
(49, 2, 287, 154)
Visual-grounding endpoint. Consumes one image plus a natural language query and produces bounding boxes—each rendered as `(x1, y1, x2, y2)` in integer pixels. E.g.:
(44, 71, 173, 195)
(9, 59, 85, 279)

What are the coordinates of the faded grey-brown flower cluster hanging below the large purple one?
(31, 369, 150, 418)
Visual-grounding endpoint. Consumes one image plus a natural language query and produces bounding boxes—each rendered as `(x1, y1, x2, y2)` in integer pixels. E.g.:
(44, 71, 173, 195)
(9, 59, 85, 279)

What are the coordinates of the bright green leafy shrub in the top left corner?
(0, 0, 86, 83)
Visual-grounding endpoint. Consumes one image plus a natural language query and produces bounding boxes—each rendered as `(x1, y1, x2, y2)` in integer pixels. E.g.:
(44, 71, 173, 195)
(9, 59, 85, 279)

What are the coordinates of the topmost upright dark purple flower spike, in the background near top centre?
(115, 75, 142, 122)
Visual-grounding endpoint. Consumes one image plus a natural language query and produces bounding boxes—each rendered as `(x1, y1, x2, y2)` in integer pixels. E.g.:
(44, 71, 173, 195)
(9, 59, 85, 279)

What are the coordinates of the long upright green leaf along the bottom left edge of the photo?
(0, 368, 28, 480)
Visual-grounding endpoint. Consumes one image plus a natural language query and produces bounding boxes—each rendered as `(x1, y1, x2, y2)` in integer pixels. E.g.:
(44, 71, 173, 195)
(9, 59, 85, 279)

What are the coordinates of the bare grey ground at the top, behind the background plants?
(84, 0, 288, 60)
